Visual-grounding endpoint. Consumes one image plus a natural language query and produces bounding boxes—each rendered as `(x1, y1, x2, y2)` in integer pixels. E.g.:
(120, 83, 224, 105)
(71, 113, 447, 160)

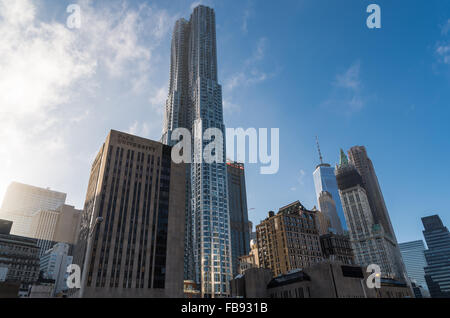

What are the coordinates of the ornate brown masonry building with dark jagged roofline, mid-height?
(256, 201, 323, 276)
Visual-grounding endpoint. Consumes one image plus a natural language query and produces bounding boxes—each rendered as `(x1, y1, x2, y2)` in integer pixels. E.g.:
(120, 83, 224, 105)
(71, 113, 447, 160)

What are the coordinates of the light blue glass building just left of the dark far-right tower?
(398, 240, 428, 289)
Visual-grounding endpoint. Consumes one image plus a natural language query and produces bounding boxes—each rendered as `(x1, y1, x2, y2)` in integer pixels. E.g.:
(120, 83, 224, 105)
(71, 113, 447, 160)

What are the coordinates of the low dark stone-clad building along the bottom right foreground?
(230, 262, 413, 298)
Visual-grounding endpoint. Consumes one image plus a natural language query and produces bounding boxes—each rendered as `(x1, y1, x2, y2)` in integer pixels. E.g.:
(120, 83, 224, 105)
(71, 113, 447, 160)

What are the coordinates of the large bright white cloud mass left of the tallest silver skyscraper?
(0, 0, 174, 204)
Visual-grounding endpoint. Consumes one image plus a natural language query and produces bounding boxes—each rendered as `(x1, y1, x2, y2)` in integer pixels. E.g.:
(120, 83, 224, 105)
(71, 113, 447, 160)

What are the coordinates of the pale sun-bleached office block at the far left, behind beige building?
(0, 182, 66, 237)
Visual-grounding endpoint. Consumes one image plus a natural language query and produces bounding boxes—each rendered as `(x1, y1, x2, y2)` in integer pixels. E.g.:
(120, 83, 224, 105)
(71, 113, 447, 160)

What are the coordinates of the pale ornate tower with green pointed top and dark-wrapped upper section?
(336, 150, 404, 279)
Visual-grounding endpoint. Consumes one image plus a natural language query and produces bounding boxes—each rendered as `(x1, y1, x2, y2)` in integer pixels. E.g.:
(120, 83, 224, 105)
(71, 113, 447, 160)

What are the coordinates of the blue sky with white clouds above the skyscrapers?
(0, 0, 450, 242)
